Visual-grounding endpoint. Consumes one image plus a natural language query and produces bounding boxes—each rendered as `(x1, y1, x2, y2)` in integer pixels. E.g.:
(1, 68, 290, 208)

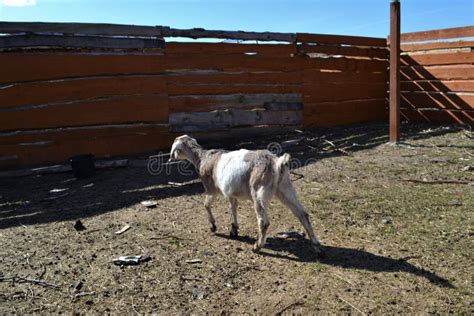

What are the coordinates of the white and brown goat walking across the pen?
(170, 135, 324, 256)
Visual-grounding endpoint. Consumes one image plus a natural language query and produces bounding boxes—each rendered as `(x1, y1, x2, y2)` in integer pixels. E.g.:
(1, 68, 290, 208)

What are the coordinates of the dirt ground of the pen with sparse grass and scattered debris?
(0, 124, 474, 314)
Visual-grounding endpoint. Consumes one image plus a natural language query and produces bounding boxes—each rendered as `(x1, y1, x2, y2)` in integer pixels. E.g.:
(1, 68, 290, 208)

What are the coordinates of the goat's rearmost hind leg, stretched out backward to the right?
(276, 178, 325, 257)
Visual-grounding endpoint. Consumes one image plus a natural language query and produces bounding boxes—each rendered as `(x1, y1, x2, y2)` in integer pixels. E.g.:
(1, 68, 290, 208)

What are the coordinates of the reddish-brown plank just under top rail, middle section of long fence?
(165, 42, 296, 57)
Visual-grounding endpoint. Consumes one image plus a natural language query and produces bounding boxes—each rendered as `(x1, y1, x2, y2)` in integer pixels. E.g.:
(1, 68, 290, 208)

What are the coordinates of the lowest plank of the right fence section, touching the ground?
(401, 107, 474, 126)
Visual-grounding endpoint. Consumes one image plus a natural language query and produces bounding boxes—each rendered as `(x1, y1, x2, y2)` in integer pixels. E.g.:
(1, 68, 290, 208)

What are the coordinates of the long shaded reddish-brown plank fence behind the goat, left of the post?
(0, 22, 388, 168)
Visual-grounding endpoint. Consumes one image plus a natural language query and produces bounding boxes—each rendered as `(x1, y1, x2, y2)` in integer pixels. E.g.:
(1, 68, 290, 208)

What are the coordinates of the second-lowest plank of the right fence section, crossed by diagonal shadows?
(401, 92, 474, 110)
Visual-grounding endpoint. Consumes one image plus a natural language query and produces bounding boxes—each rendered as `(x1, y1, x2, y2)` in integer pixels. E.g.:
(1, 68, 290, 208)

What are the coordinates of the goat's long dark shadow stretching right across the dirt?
(216, 234, 454, 288)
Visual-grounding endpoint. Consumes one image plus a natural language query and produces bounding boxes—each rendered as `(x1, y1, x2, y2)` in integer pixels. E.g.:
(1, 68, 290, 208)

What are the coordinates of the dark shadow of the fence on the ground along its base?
(0, 123, 466, 229)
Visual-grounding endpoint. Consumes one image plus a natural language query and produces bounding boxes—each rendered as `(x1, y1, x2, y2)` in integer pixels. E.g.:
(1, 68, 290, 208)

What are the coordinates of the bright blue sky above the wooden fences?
(0, 0, 474, 37)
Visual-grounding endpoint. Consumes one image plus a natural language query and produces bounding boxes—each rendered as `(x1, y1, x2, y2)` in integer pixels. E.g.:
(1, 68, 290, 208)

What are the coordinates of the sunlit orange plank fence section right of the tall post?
(400, 26, 474, 126)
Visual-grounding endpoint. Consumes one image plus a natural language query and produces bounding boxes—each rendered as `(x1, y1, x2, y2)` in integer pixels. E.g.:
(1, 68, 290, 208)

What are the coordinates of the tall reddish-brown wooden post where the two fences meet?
(390, 0, 400, 143)
